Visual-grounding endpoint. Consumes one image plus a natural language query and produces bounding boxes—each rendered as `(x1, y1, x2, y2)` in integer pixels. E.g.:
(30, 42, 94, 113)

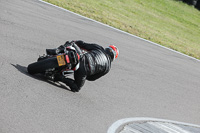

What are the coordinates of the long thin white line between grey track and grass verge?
(38, 0, 200, 62)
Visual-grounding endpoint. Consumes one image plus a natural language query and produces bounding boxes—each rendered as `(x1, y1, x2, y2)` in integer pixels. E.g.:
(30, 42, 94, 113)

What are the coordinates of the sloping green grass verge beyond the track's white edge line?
(45, 0, 200, 59)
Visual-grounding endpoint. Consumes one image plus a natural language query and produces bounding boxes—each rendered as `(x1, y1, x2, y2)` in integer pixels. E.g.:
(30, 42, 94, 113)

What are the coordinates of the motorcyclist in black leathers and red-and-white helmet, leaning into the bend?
(47, 40, 119, 92)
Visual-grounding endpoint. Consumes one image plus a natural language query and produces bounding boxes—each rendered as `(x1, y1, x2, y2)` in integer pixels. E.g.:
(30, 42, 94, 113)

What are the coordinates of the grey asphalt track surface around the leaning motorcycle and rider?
(0, 0, 200, 133)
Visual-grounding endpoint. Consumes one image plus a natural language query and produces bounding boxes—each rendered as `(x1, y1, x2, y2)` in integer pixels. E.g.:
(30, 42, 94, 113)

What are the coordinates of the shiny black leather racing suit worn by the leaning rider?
(62, 41, 111, 92)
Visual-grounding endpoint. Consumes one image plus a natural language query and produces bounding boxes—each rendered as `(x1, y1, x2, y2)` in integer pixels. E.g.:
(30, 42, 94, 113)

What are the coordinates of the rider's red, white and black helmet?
(105, 45, 119, 61)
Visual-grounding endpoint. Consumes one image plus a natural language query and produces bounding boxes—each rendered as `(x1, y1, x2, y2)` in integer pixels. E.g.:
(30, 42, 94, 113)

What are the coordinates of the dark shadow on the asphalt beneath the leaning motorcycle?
(11, 64, 70, 91)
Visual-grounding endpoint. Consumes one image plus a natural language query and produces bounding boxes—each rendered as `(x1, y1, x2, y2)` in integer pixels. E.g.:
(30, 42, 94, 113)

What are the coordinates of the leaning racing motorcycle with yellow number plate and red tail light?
(27, 44, 82, 80)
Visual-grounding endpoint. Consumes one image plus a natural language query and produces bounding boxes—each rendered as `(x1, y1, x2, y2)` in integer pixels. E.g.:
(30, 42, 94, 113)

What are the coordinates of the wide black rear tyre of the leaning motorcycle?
(27, 57, 59, 74)
